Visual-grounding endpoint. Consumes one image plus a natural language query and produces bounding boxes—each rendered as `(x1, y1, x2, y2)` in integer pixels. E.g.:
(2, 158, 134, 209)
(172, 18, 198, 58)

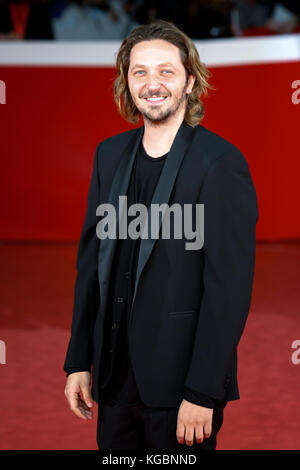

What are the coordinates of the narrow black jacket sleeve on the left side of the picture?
(64, 144, 101, 373)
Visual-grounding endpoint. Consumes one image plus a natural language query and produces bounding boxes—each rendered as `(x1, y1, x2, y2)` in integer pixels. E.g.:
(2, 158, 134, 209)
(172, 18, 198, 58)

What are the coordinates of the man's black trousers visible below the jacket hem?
(97, 402, 223, 453)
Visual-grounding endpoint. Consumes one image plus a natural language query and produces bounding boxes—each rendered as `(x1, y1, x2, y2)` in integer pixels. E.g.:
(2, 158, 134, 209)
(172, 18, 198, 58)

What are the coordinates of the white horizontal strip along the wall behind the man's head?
(0, 34, 300, 67)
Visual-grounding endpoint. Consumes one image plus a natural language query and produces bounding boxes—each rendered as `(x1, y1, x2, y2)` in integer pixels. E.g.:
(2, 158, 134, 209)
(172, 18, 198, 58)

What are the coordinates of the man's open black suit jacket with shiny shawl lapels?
(64, 121, 258, 407)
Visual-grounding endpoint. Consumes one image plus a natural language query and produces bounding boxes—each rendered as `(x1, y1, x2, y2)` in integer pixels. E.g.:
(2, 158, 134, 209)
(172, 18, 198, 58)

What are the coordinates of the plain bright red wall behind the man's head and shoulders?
(0, 61, 300, 240)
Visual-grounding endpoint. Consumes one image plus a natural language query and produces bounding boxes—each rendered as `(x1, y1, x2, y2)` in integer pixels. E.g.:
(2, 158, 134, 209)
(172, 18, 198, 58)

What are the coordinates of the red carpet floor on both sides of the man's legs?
(0, 242, 300, 449)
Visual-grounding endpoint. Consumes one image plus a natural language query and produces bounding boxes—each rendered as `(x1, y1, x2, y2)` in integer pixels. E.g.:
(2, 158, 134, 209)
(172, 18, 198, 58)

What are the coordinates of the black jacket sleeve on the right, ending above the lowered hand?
(184, 146, 258, 400)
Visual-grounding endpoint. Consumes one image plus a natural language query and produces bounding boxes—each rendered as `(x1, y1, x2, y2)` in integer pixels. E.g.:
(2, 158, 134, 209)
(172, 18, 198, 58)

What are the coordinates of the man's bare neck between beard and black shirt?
(143, 110, 184, 157)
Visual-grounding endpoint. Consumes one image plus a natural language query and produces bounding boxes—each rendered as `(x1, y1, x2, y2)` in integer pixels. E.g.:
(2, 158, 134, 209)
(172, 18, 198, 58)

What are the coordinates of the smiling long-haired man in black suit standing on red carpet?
(64, 21, 258, 451)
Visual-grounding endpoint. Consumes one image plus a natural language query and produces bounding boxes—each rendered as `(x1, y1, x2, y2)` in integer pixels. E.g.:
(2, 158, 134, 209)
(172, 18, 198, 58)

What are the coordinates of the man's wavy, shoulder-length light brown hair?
(114, 20, 213, 127)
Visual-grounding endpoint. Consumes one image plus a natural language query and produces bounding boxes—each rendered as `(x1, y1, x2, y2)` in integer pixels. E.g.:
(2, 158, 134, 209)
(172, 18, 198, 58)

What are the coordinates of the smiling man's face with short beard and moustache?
(128, 39, 194, 122)
